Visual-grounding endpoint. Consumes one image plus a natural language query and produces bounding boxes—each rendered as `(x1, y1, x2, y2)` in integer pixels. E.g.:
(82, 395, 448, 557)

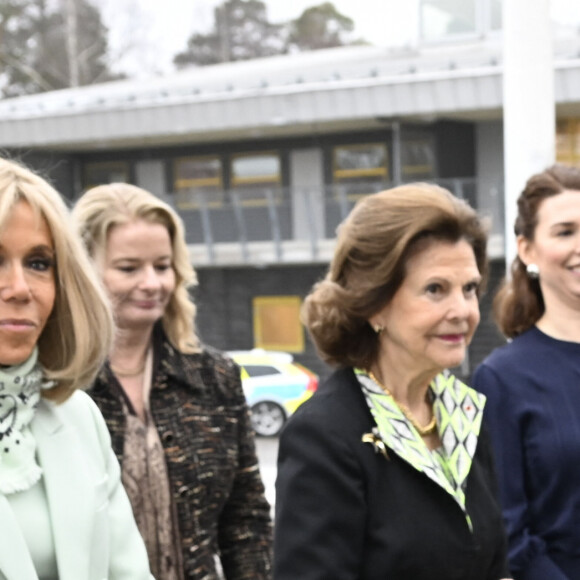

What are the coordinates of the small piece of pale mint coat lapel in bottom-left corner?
(0, 494, 38, 580)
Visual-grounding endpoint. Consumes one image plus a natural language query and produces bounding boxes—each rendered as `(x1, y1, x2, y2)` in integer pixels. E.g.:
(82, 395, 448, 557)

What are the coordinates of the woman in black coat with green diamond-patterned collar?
(274, 183, 507, 580)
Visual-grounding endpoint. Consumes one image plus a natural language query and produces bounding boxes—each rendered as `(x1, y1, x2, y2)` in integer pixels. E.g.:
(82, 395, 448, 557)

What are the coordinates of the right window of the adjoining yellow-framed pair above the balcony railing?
(231, 152, 282, 205)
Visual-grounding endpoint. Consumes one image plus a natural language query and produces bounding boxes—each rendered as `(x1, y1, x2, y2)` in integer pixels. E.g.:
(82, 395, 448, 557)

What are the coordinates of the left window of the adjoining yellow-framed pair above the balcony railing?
(174, 156, 224, 209)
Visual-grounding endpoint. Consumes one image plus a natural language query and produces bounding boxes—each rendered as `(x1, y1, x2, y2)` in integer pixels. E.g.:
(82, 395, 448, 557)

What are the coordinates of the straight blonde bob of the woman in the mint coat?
(0, 158, 114, 402)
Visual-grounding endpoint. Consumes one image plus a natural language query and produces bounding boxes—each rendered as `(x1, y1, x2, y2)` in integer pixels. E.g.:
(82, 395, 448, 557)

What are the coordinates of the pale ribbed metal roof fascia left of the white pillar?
(0, 67, 502, 147)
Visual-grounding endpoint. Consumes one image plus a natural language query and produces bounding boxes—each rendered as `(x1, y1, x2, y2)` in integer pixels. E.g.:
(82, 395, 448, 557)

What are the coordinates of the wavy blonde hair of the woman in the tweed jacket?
(73, 183, 199, 353)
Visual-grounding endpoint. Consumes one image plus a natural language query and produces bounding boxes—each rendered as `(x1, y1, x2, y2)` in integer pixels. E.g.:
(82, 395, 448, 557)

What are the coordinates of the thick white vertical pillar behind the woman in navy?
(503, 0, 556, 271)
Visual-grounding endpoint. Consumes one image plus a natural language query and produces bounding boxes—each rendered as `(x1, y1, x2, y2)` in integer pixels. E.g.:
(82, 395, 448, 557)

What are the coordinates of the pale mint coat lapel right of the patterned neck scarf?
(32, 399, 95, 580)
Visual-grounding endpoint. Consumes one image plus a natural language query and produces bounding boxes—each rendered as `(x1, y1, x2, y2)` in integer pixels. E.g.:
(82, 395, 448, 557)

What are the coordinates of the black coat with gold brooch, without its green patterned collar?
(274, 369, 509, 580)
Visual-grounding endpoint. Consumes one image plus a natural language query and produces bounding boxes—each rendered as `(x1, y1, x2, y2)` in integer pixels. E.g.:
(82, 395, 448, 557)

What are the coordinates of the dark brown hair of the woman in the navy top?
(493, 164, 580, 338)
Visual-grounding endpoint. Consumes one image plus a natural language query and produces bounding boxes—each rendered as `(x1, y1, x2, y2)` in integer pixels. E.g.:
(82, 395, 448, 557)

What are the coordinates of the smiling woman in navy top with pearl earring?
(472, 165, 580, 580)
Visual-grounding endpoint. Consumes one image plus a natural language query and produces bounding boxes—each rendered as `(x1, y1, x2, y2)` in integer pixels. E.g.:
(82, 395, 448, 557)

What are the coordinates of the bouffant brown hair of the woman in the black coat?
(302, 183, 487, 368)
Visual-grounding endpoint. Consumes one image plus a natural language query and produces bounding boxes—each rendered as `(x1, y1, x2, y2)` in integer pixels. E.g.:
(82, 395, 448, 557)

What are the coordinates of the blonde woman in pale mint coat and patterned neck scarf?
(0, 159, 151, 580)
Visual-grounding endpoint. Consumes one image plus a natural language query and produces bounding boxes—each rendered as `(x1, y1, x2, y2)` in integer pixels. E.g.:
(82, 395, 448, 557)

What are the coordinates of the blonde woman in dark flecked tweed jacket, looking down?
(73, 184, 271, 580)
